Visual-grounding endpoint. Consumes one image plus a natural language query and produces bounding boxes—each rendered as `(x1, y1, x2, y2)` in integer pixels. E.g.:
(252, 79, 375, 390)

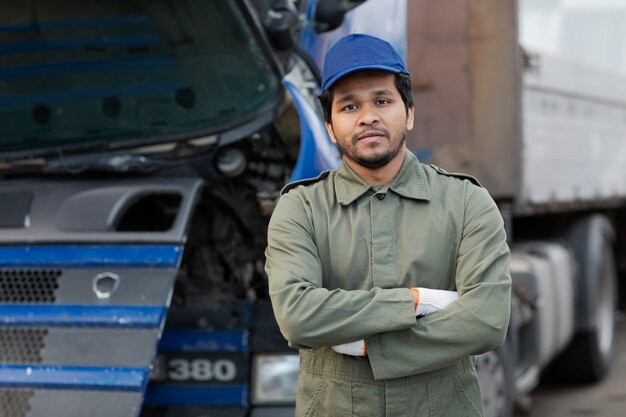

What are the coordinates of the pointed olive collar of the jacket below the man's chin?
(334, 149, 430, 206)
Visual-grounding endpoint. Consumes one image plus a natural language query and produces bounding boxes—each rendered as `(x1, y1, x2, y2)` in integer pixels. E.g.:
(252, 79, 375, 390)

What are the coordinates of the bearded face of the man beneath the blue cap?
(326, 71, 414, 169)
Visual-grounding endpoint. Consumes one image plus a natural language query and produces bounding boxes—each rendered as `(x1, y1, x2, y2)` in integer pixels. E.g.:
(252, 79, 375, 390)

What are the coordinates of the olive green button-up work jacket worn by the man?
(266, 152, 511, 415)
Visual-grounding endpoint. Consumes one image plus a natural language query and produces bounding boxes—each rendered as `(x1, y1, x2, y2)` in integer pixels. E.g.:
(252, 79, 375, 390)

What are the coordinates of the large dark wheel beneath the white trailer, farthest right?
(549, 215, 617, 382)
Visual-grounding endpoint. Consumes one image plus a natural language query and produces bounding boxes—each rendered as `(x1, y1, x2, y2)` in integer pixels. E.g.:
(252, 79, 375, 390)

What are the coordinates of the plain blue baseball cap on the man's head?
(322, 33, 410, 91)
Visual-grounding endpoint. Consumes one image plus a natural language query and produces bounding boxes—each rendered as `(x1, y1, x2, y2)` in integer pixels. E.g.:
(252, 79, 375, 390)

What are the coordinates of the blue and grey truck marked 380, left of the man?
(0, 0, 358, 417)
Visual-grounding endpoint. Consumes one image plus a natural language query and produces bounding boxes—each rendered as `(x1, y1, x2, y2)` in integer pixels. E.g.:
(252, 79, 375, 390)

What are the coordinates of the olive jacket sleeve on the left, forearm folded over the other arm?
(265, 191, 416, 348)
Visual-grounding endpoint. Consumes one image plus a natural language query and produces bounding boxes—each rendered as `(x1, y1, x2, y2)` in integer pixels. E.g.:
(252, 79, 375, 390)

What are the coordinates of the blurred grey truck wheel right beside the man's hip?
(476, 343, 513, 417)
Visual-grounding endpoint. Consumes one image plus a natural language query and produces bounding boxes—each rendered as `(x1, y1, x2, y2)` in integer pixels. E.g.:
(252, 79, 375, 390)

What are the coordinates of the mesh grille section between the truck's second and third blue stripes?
(0, 327, 48, 364)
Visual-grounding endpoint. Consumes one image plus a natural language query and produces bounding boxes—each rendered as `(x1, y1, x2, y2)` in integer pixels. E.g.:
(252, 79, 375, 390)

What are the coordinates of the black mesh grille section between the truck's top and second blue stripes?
(0, 269, 61, 303)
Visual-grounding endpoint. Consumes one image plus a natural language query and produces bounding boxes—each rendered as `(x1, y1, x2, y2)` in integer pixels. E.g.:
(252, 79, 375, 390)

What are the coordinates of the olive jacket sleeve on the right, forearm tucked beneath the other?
(365, 188, 511, 379)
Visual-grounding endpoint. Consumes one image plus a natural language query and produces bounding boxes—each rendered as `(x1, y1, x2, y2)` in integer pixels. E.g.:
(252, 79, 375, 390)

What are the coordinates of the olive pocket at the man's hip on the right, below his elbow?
(427, 368, 484, 417)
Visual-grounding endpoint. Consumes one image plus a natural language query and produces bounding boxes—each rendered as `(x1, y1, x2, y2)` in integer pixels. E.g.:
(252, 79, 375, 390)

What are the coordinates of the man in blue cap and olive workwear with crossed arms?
(266, 34, 510, 417)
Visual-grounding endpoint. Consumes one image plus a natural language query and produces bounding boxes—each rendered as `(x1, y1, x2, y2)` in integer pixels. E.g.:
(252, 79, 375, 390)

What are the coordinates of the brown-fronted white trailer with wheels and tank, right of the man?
(407, 0, 626, 416)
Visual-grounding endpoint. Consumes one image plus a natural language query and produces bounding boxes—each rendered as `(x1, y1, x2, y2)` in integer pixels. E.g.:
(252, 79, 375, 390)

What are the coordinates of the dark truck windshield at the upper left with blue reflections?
(0, 0, 280, 155)
